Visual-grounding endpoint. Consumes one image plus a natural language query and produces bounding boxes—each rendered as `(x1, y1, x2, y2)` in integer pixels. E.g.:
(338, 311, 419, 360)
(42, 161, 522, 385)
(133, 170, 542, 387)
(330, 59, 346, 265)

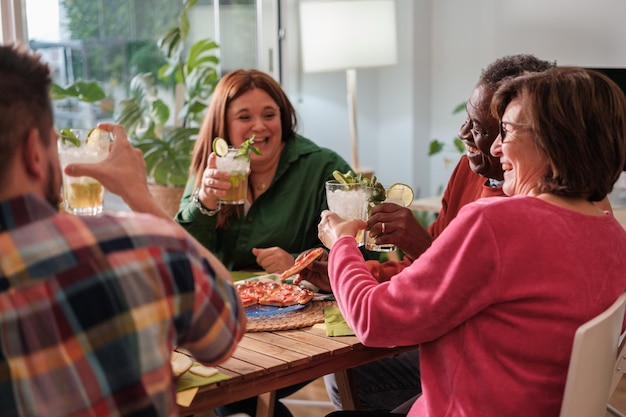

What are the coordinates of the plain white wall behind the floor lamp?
(284, 0, 626, 196)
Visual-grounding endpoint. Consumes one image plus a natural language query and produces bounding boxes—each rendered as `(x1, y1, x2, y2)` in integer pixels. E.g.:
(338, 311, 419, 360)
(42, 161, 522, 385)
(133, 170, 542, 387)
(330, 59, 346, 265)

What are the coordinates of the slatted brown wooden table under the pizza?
(180, 327, 415, 417)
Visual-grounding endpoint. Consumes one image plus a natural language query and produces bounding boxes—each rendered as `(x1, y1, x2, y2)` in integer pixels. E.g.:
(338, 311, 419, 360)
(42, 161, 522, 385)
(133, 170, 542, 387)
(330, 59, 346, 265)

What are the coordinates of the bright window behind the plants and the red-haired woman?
(6, 0, 279, 127)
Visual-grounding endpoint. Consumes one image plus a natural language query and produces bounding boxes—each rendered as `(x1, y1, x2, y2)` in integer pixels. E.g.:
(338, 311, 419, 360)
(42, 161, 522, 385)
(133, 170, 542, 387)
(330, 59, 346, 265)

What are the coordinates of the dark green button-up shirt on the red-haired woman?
(176, 135, 350, 271)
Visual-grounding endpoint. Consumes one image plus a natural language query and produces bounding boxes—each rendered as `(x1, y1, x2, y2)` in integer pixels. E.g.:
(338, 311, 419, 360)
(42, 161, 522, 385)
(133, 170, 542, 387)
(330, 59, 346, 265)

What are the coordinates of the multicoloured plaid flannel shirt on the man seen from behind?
(0, 195, 245, 417)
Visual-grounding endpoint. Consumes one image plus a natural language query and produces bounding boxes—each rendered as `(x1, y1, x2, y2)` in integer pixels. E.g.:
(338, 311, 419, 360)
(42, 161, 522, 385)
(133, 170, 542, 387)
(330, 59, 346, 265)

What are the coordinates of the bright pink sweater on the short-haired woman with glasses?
(329, 196, 626, 417)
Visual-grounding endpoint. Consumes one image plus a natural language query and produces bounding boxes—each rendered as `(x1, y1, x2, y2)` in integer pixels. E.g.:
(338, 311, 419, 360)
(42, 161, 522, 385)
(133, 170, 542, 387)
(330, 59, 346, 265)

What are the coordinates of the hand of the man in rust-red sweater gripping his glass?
(366, 203, 433, 258)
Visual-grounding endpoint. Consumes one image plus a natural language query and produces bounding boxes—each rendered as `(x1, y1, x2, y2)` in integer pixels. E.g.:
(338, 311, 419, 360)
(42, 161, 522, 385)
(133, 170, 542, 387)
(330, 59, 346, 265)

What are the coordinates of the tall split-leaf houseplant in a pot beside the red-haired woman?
(115, 0, 219, 215)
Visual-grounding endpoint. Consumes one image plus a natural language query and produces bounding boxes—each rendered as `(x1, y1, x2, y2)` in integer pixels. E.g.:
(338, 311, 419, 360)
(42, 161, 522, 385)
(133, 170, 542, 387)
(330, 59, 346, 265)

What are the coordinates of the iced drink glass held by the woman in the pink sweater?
(326, 180, 372, 246)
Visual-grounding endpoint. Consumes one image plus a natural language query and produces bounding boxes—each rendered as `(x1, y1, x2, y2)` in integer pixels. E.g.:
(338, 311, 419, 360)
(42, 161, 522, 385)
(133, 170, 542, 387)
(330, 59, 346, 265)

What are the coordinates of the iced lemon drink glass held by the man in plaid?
(58, 129, 111, 216)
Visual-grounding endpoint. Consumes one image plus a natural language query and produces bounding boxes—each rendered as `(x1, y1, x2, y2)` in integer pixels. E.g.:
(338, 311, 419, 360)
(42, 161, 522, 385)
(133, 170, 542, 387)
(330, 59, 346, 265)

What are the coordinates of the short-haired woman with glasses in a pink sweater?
(319, 67, 626, 417)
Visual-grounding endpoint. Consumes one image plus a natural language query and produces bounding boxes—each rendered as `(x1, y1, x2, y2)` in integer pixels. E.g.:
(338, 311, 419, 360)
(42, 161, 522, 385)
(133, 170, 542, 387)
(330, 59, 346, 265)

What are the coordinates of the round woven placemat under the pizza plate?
(246, 301, 337, 332)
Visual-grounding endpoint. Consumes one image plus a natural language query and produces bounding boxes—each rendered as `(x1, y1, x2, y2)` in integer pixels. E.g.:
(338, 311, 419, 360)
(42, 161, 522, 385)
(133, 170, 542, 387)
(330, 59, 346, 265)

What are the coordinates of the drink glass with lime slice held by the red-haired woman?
(216, 147, 250, 204)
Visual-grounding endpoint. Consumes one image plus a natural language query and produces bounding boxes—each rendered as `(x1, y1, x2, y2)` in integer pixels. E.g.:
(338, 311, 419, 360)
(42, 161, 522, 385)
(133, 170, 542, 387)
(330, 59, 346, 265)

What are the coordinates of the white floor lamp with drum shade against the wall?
(300, 0, 397, 171)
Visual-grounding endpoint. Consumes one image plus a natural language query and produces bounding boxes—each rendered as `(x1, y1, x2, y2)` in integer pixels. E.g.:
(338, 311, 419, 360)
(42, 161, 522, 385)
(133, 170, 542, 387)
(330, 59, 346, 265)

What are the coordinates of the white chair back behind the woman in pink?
(560, 293, 626, 417)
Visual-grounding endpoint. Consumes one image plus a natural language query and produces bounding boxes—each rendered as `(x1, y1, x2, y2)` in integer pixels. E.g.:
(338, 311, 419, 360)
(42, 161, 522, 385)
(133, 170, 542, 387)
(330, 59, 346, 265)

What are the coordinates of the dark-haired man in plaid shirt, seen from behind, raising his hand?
(0, 46, 245, 417)
